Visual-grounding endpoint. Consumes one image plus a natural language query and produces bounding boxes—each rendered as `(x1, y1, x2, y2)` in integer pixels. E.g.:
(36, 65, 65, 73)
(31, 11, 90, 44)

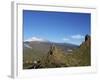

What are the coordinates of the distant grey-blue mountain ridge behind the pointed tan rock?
(23, 41, 79, 53)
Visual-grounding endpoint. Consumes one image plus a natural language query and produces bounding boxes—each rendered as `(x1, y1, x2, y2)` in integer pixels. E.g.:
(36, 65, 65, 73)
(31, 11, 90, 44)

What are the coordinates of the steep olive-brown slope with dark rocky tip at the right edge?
(73, 35, 91, 66)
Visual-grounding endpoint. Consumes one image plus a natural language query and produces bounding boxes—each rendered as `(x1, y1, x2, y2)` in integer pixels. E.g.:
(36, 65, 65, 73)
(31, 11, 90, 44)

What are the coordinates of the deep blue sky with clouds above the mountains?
(23, 10, 91, 45)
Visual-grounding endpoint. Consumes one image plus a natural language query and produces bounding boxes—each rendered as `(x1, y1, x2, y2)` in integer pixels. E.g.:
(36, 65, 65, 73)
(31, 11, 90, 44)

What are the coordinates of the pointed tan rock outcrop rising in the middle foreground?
(46, 45, 66, 67)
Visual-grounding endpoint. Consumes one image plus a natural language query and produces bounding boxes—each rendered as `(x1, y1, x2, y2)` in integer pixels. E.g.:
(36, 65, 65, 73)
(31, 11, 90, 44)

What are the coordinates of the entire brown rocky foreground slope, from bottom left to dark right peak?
(24, 35, 91, 69)
